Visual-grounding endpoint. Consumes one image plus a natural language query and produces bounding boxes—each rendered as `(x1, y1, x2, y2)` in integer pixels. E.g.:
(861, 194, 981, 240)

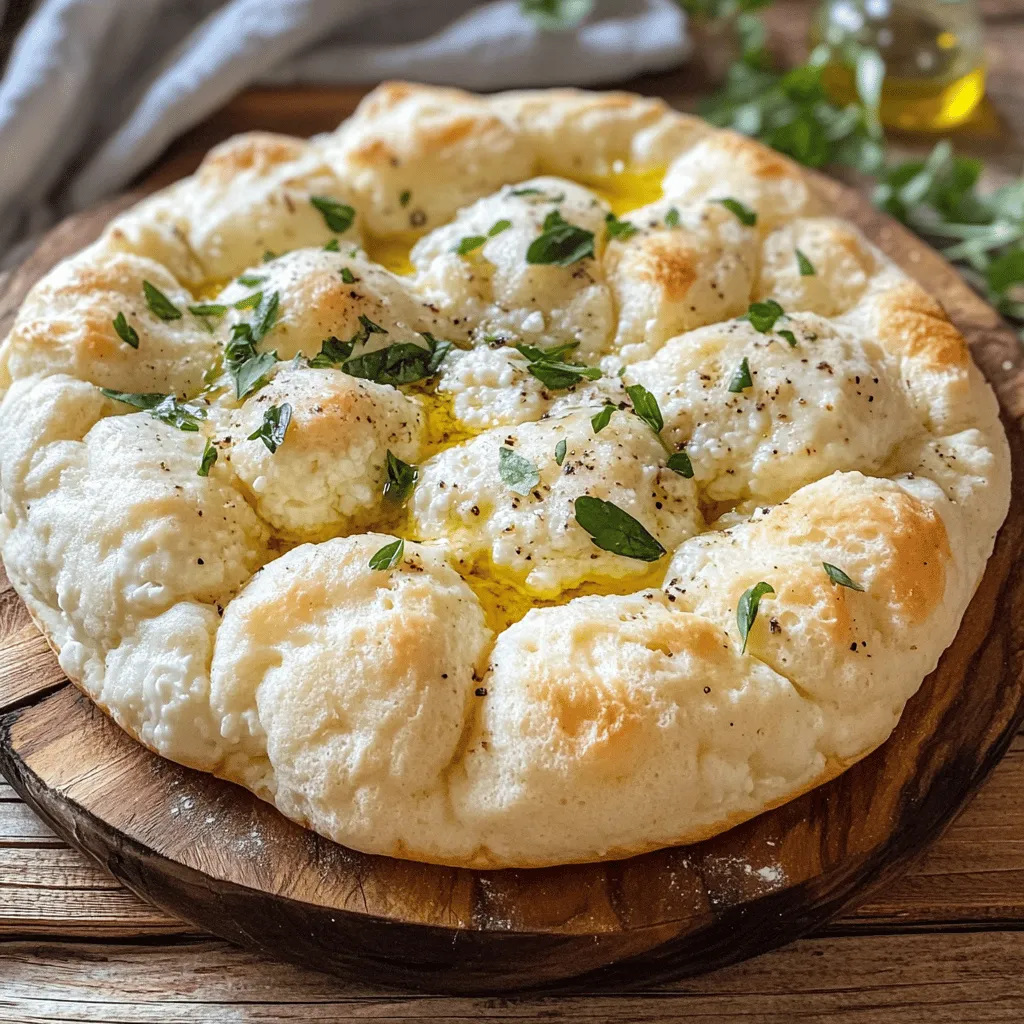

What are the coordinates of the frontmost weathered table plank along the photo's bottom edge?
(0, 931, 1024, 1024)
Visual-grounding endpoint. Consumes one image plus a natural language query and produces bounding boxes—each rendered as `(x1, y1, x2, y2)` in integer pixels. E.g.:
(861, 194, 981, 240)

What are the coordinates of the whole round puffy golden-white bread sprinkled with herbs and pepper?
(0, 83, 1010, 867)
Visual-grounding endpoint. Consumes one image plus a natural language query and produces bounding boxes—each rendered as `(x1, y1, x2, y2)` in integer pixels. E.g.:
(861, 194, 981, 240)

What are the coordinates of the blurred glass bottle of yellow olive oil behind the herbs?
(811, 0, 985, 132)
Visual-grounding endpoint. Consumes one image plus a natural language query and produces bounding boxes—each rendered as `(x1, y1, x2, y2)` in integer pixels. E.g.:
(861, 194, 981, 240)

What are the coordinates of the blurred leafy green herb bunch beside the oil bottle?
(677, 0, 1024, 340)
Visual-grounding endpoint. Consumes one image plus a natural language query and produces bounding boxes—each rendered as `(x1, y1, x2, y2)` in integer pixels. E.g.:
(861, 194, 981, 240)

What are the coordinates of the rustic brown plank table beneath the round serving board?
(0, 0, 1024, 1024)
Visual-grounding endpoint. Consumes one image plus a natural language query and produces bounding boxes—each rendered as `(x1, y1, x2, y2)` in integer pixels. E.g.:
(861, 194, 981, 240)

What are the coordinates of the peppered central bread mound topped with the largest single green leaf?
(412, 407, 703, 597)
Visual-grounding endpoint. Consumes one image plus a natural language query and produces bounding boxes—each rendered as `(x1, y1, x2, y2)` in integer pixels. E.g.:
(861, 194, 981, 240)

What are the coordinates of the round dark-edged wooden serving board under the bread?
(0, 169, 1024, 992)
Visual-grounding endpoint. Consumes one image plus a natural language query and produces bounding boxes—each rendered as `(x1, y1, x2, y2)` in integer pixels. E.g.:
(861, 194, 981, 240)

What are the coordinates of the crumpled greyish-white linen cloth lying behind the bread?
(0, 0, 688, 260)
